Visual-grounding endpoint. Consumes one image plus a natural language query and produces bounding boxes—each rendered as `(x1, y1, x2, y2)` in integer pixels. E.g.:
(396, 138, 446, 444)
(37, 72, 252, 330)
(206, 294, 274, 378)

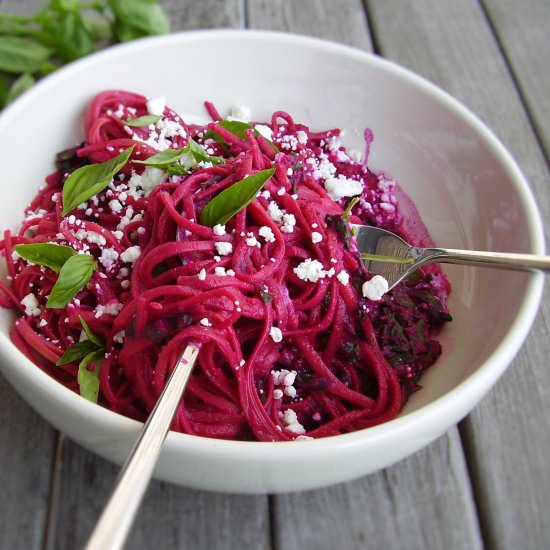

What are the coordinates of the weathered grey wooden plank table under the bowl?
(0, 0, 550, 550)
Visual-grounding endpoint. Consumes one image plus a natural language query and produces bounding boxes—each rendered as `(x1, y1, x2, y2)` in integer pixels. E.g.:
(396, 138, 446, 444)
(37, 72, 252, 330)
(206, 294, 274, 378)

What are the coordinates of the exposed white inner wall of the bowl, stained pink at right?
(0, 33, 540, 440)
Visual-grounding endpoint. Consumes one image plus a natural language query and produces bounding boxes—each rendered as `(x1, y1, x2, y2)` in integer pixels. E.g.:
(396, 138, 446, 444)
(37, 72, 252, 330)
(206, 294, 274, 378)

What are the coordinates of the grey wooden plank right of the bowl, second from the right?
(368, 0, 550, 549)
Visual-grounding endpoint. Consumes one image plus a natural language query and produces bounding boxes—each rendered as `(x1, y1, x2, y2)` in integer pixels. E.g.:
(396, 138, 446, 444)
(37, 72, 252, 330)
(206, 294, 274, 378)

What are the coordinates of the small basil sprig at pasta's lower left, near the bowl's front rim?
(56, 315, 105, 403)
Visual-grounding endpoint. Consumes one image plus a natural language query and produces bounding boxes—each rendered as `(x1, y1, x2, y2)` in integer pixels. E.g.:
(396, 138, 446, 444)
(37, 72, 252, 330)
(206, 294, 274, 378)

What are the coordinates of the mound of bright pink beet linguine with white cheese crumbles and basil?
(0, 91, 450, 441)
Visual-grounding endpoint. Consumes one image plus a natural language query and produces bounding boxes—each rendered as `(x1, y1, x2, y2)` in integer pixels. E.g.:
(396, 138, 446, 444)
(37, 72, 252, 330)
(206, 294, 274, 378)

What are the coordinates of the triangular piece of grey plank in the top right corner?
(483, 0, 550, 158)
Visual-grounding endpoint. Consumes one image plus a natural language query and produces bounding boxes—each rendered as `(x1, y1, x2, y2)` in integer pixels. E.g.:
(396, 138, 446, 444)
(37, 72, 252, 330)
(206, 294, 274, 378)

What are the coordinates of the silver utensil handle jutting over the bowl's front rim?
(86, 344, 199, 550)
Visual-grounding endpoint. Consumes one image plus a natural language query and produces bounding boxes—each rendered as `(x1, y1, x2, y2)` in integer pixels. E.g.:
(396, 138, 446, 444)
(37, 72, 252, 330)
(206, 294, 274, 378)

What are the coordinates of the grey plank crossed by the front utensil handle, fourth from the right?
(41, 0, 269, 550)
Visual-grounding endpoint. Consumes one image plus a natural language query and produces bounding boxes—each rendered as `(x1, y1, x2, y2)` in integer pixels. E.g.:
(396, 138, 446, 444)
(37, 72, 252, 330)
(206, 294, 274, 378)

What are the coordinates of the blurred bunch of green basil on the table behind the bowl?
(0, 0, 170, 107)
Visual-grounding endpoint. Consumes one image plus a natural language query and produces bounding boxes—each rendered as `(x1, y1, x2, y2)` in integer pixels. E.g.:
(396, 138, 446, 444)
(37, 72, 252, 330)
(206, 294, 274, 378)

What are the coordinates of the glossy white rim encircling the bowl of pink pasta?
(0, 29, 544, 462)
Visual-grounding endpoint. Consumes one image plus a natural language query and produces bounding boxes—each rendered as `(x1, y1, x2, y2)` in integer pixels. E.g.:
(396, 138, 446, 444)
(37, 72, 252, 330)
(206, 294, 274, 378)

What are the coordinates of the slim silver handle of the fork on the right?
(422, 248, 550, 271)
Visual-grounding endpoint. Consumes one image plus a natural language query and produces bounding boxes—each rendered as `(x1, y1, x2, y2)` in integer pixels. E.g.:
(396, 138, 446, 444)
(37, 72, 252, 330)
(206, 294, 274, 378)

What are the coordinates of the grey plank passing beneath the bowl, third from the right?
(248, 0, 481, 550)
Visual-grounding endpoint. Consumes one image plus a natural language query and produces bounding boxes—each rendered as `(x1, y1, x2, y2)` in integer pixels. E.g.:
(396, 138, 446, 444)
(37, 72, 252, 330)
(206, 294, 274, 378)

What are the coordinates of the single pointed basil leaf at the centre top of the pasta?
(200, 168, 275, 227)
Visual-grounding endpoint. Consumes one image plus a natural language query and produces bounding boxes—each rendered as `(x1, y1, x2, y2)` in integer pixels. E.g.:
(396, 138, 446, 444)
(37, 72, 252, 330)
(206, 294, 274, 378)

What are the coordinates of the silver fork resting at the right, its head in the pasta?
(351, 224, 550, 289)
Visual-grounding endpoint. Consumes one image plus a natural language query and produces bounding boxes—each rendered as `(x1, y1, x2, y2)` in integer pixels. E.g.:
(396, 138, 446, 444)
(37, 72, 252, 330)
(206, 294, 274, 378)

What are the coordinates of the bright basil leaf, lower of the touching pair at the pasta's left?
(46, 254, 97, 308)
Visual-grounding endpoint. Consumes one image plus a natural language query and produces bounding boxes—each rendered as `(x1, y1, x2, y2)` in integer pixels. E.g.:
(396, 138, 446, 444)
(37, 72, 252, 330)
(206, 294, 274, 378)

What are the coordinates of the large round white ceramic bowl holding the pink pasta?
(0, 31, 543, 493)
